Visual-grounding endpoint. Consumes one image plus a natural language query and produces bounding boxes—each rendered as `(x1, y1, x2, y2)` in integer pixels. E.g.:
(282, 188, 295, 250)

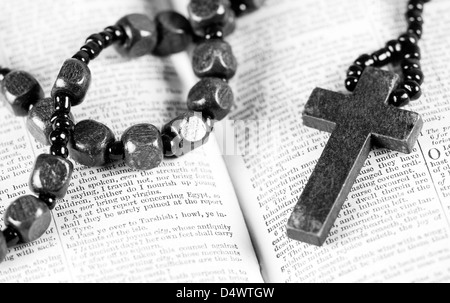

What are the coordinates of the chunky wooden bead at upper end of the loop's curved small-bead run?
(117, 14, 158, 57)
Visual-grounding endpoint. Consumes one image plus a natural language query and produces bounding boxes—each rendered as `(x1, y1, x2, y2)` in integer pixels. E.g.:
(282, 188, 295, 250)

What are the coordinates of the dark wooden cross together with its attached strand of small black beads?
(287, 0, 430, 246)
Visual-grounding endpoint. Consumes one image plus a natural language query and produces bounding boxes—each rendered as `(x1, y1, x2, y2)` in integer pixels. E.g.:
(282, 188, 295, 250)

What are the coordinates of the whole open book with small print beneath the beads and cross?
(0, 0, 450, 282)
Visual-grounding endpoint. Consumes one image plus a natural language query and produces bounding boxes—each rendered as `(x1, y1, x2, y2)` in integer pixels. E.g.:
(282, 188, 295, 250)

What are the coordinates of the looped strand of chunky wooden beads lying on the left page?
(0, 0, 264, 262)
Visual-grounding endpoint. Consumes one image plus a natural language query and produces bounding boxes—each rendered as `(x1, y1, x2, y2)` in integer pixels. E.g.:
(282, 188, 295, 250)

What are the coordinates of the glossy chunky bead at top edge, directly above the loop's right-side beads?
(188, 0, 235, 37)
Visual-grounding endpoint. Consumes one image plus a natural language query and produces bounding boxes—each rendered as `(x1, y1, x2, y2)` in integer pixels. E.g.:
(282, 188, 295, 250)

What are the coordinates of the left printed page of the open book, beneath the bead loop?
(0, 0, 262, 282)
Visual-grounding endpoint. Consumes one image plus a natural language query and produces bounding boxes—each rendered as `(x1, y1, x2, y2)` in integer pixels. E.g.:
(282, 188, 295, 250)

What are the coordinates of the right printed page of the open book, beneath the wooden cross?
(224, 0, 450, 282)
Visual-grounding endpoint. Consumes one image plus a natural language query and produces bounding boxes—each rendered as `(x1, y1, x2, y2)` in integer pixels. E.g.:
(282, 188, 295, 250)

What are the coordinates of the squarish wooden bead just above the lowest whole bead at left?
(29, 154, 73, 199)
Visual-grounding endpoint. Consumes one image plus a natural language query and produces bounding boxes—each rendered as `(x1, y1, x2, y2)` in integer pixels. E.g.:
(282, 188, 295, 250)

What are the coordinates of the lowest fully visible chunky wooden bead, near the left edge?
(4, 196, 52, 243)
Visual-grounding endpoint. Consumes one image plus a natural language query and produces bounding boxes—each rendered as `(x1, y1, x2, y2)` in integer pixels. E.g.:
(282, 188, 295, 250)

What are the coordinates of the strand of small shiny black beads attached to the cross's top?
(345, 0, 430, 107)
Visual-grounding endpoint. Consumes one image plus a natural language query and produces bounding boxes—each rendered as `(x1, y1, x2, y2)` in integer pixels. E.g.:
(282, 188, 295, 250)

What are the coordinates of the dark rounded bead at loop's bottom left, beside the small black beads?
(69, 120, 116, 167)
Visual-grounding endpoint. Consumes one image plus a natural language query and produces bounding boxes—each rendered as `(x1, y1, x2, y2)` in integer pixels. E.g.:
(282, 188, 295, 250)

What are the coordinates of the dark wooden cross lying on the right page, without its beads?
(287, 67, 423, 246)
